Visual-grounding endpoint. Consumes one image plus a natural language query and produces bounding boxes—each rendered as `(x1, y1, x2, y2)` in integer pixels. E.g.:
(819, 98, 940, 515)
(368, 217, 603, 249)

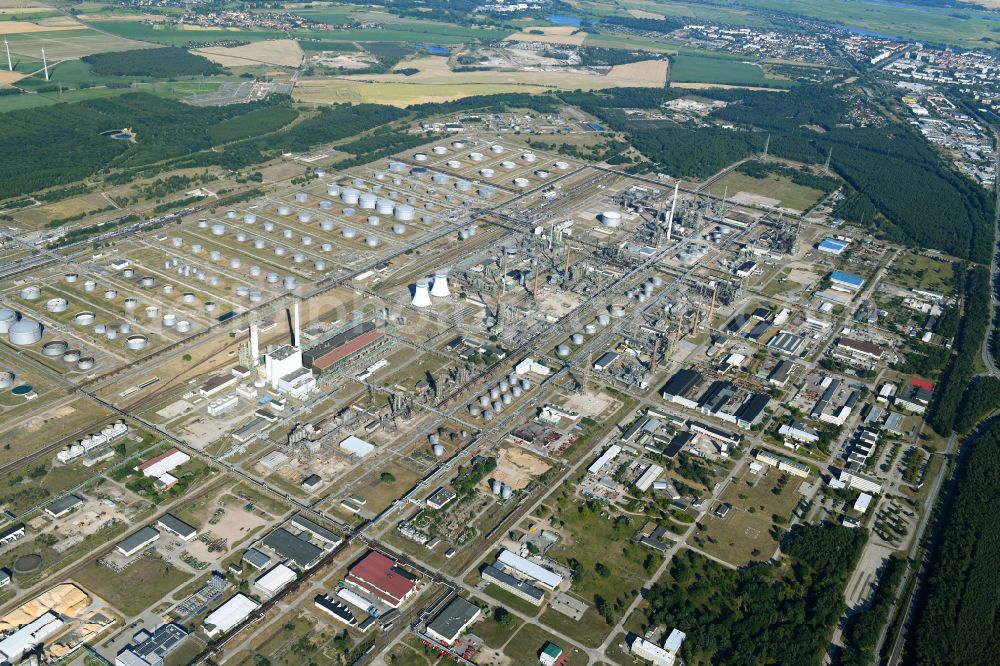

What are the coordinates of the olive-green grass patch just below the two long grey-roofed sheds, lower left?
(75, 557, 192, 615)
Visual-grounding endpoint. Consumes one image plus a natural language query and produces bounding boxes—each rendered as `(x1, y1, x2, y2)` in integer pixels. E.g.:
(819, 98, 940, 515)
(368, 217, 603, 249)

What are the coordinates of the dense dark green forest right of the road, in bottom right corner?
(905, 423, 1000, 666)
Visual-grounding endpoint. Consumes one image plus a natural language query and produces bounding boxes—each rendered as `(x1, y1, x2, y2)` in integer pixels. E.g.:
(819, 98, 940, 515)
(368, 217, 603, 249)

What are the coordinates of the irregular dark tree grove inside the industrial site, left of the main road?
(647, 523, 867, 666)
